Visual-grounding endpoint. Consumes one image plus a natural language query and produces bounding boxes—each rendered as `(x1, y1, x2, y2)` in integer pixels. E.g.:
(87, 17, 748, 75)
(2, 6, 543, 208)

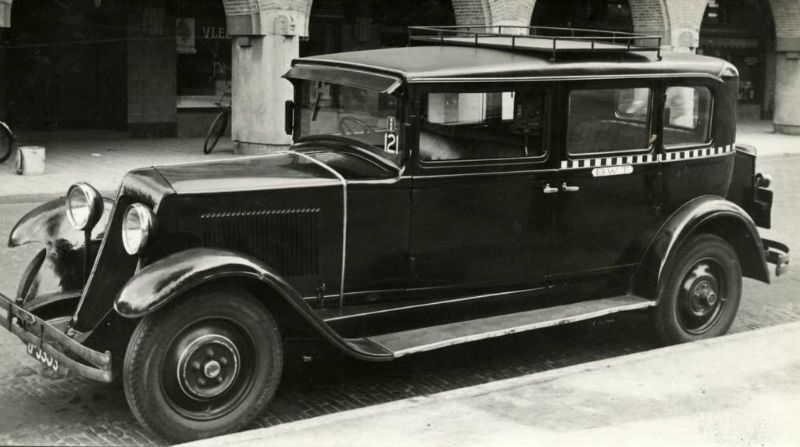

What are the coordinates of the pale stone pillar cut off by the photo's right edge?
(772, 50, 800, 135)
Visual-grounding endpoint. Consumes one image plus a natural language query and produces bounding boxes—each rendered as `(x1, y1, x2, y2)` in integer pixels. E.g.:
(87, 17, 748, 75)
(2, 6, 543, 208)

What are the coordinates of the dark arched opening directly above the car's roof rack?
(531, 0, 633, 32)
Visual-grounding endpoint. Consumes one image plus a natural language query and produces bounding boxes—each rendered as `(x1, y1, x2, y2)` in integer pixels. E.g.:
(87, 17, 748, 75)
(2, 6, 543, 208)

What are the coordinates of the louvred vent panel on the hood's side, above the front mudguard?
(200, 208, 319, 276)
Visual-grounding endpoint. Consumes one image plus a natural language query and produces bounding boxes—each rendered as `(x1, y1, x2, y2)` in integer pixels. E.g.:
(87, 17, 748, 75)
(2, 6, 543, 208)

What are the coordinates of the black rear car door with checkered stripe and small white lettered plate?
(553, 81, 661, 287)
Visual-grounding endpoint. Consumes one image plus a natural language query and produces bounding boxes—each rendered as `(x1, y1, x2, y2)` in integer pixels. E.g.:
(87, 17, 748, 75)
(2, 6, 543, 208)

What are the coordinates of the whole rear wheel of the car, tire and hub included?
(652, 234, 742, 344)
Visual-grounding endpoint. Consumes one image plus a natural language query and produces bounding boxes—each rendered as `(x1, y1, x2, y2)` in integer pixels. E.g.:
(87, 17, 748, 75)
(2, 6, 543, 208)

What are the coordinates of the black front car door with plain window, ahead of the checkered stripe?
(409, 88, 555, 299)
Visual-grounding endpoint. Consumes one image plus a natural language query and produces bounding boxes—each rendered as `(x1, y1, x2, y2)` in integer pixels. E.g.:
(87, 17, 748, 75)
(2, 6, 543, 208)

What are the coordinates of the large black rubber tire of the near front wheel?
(122, 288, 283, 442)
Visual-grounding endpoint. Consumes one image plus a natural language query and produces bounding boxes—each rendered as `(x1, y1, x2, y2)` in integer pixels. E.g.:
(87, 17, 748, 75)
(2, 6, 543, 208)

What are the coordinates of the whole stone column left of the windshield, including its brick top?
(225, 0, 311, 154)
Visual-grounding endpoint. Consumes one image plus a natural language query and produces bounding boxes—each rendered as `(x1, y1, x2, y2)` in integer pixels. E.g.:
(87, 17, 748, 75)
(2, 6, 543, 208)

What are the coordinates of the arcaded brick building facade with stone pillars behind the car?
(0, 0, 800, 149)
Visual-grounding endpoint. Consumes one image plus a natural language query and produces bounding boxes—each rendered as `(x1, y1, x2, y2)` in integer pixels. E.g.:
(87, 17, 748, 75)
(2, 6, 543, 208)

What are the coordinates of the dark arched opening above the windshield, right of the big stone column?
(300, 0, 455, 56)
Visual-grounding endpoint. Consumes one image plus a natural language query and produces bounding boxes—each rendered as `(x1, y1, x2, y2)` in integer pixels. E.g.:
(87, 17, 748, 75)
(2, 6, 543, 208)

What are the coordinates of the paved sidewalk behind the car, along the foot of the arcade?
(0, 121, 800, 203)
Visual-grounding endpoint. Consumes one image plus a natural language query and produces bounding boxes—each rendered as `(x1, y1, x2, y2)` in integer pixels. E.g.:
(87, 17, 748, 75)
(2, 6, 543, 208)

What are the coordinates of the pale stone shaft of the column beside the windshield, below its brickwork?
(231, 35, 300, 154)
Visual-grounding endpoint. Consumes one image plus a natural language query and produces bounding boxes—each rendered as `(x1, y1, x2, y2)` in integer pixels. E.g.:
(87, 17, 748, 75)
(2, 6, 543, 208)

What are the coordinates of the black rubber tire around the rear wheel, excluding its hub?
(651, 234, 742, 344)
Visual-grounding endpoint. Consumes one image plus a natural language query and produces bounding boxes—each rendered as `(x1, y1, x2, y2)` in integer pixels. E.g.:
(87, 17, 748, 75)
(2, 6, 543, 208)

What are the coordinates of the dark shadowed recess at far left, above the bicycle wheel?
(2, 0, 127, 130)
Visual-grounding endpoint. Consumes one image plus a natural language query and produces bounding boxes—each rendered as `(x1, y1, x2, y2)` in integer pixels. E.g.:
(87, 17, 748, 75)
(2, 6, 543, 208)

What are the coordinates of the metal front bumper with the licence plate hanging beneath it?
(0, 293, 112, 382)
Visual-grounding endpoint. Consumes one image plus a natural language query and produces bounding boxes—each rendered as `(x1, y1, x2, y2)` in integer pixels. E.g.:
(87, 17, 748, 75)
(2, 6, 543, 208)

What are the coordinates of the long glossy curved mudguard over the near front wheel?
(114, 248, 391, 360)
